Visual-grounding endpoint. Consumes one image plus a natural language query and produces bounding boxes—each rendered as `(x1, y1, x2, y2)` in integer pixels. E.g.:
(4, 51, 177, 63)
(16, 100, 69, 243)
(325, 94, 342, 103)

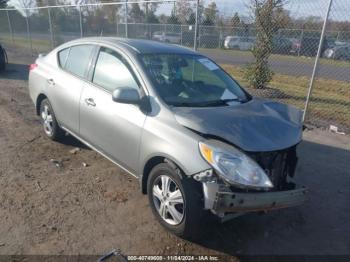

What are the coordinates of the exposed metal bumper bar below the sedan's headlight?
(212, 188, 308, 213)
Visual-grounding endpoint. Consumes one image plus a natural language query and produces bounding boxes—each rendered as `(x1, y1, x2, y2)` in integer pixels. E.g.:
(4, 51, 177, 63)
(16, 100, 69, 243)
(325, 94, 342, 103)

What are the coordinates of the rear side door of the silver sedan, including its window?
(47, 44, 95, 133)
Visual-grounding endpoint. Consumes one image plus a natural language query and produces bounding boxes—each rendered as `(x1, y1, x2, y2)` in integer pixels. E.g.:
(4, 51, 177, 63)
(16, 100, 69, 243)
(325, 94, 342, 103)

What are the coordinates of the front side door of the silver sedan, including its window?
(80, 47, 146, 174)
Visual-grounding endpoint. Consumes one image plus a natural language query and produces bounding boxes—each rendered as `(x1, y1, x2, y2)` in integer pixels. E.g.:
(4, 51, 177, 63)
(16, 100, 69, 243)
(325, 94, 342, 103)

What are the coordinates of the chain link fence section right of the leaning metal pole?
(305, 0, 350, 133)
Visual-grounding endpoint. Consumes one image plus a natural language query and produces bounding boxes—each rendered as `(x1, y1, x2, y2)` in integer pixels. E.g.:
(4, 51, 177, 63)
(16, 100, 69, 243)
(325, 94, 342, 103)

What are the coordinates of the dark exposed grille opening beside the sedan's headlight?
(247, 146, 298, 190)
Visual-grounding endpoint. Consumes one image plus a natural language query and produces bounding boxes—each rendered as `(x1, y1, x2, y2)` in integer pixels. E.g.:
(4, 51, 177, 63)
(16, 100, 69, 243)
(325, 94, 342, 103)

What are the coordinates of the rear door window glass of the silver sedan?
(64, 45, 94, 77)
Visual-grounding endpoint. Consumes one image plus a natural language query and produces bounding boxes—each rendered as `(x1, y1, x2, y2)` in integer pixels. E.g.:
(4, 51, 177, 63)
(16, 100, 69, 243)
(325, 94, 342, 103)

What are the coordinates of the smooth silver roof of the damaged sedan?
(65, 37, 198, 54)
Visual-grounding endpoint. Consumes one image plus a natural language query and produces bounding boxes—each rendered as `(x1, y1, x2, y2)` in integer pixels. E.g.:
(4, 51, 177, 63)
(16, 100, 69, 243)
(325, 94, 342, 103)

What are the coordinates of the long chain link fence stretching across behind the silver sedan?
(0, 0, 350, 132)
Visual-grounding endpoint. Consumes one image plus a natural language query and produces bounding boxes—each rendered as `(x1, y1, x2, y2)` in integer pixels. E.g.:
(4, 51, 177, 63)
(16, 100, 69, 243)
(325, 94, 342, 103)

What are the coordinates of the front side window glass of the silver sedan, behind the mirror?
(92, 48, 139, 92)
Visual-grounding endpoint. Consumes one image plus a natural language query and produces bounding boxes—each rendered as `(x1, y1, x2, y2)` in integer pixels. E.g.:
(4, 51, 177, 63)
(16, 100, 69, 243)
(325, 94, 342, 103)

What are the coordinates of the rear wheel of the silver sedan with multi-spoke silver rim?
(40, 99, 65, 141)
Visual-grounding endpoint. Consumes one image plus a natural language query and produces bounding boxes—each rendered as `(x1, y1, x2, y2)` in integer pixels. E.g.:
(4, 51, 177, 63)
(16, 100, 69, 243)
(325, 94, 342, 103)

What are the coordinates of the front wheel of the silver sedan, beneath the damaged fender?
(147, 163, 204, 239)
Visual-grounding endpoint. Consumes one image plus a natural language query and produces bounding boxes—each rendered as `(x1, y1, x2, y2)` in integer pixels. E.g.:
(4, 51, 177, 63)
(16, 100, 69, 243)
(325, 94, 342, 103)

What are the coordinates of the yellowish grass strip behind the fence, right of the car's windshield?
(222, 65, 350, 128)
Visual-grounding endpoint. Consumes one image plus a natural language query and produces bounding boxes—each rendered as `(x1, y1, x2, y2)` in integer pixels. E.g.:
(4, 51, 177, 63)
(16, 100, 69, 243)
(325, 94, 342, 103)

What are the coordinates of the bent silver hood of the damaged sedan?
(172, 98, 302, 152)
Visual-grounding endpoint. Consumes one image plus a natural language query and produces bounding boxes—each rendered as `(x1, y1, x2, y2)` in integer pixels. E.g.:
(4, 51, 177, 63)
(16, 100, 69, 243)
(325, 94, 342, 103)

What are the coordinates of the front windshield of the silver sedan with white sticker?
(141, 54, 249, 107)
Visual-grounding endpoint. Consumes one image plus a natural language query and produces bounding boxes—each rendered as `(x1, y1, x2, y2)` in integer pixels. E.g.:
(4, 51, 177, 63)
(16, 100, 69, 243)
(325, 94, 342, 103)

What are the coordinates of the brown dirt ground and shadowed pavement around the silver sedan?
(0, 48, 350, 256)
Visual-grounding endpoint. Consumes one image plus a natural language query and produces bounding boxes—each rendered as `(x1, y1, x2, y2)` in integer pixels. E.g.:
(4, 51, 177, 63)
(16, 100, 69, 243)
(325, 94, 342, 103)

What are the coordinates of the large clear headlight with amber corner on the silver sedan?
(199, 142, 273, 188)
